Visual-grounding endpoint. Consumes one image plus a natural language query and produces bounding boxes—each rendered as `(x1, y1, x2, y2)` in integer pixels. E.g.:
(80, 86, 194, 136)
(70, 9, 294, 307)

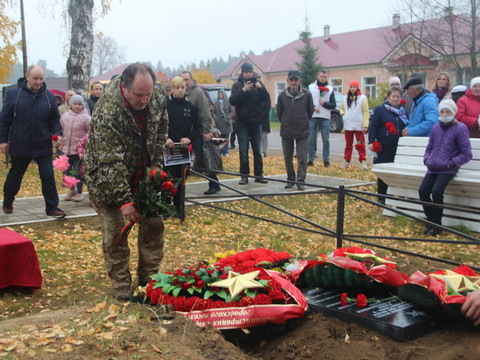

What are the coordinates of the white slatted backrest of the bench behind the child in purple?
(394, 136, 480, 171)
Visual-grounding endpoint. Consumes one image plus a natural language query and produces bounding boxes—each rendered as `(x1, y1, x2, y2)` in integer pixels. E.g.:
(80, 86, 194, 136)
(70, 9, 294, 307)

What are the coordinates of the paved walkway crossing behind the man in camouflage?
(0, 174, 373, 227)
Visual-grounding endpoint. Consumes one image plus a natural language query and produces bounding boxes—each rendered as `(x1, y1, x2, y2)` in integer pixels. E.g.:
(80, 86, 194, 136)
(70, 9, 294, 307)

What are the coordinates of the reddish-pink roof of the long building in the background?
(219, 16, 478, 77)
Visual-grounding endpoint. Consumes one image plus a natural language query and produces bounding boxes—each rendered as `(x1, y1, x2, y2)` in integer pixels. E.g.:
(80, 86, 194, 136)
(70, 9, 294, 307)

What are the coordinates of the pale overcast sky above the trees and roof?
(8, 0, 396, 74)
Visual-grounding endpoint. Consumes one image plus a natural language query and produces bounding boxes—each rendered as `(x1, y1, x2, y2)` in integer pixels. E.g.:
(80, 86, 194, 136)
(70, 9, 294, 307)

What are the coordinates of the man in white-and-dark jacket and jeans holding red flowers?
(307, 70, 337, 167)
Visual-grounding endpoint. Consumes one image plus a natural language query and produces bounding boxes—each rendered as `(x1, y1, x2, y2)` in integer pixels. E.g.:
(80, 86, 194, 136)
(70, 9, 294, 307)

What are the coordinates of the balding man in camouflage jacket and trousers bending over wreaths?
(85, 63, 168, 300)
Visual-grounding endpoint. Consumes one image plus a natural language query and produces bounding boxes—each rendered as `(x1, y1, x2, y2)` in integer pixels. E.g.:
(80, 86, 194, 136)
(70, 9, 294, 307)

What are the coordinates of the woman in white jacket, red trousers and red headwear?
(340, 81, 369, 170)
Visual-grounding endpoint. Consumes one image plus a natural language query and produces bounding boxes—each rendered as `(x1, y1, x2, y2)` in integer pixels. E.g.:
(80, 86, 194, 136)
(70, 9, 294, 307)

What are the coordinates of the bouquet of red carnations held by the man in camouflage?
(111, 170, 182, 246)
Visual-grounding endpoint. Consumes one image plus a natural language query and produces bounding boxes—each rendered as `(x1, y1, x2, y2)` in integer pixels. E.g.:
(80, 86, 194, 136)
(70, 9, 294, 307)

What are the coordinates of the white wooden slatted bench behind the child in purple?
(372, 137, 480, 232)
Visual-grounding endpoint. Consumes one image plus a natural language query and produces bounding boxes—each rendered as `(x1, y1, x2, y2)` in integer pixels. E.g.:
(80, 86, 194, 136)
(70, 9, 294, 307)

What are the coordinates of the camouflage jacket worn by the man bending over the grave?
(84, 76, 168, 207)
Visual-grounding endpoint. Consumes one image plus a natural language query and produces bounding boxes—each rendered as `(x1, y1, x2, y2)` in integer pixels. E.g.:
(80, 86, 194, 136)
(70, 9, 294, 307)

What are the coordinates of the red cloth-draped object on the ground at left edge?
(0, 229, 42, 288)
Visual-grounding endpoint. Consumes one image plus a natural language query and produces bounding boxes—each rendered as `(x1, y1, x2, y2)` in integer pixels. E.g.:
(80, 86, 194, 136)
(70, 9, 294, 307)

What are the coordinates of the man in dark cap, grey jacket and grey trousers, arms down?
(277, 70, 314, 190)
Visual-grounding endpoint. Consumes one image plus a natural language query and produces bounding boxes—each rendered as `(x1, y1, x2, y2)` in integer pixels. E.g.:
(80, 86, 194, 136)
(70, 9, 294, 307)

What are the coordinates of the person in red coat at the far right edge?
(455, 76, 480, 138)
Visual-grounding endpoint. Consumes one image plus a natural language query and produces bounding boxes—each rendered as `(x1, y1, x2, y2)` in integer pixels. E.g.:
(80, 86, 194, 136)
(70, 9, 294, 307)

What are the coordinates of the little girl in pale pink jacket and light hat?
(60, 95, 91, 201)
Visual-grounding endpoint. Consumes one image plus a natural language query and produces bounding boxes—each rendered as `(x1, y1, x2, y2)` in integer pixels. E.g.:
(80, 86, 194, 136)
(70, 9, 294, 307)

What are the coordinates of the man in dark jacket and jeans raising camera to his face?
(229, 62, 270, 185)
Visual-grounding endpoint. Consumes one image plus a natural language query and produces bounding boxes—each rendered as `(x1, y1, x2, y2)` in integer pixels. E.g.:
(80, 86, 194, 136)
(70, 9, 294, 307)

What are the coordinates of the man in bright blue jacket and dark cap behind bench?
(402, 77, 438, 136)
